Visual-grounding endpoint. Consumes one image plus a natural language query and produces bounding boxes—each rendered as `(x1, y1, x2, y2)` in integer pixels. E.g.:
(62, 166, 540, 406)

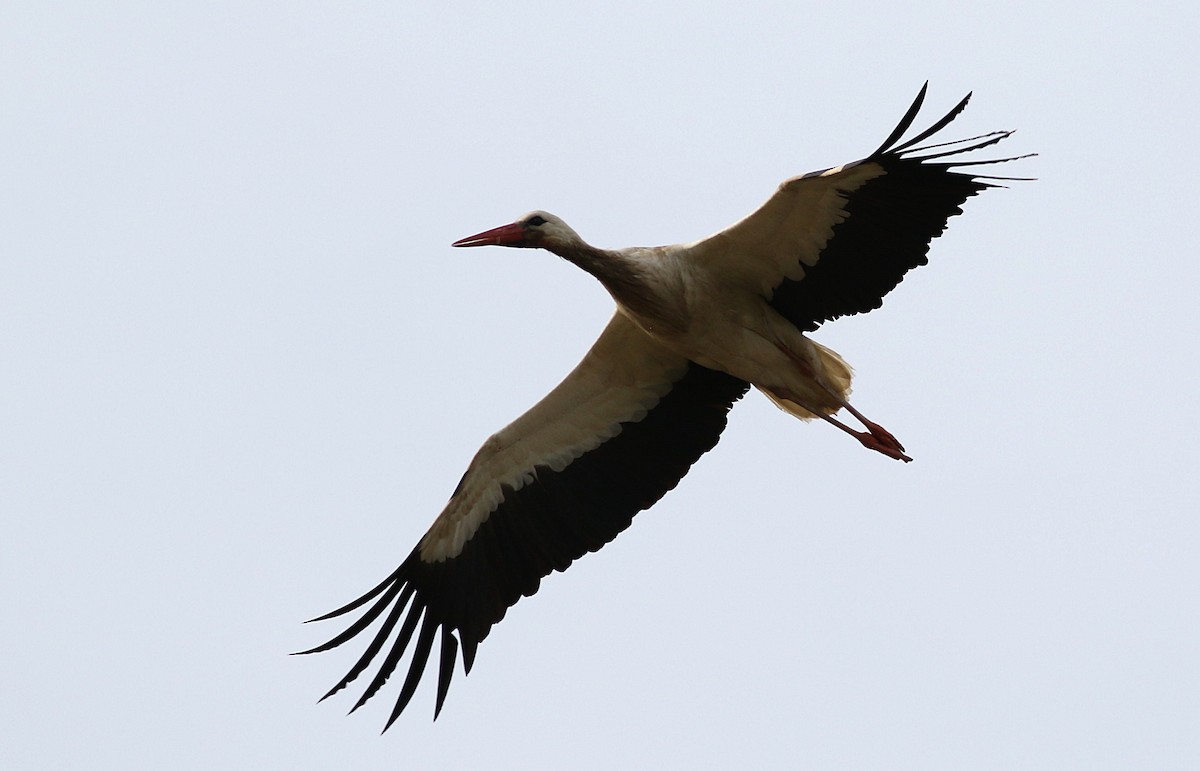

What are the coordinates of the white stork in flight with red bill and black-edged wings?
(302, 83, 1026, 730)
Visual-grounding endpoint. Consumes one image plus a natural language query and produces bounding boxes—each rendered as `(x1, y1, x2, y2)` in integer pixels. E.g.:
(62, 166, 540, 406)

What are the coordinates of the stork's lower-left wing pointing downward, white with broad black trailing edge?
(297, 312, 749, 725)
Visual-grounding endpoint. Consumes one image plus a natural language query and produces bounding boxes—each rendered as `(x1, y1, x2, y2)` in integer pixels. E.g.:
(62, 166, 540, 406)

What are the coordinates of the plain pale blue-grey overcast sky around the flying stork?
(0, 0, 1200, 770)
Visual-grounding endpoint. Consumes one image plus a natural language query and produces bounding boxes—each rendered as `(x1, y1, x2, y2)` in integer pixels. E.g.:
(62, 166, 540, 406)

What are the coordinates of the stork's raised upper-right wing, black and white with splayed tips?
(688, 84, 1026, 330)
